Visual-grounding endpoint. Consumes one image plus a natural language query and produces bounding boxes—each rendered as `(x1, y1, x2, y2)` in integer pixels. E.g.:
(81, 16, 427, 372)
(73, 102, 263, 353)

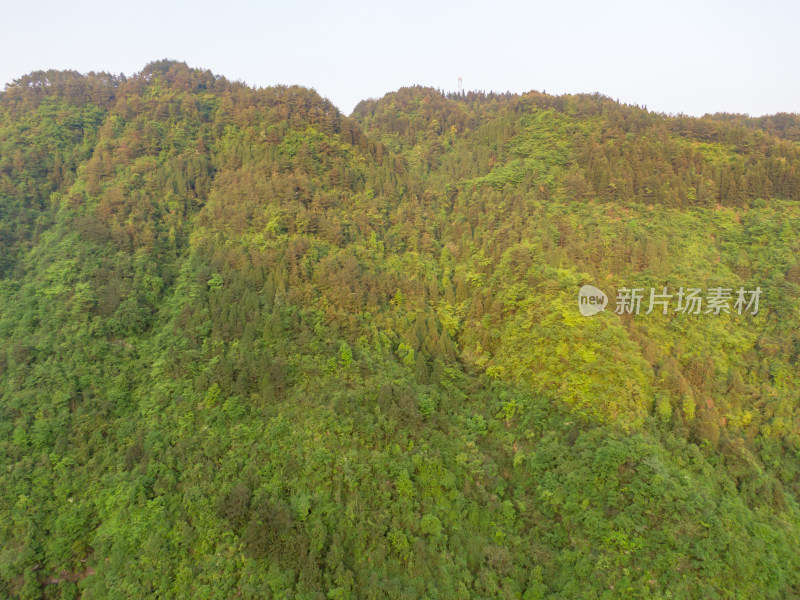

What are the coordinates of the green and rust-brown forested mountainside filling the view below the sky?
(0, 61, 800, 600)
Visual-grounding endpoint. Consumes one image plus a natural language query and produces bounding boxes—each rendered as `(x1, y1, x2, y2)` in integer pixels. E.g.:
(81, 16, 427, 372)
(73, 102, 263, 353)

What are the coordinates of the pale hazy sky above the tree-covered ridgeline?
(0, 0, 800, 115)
